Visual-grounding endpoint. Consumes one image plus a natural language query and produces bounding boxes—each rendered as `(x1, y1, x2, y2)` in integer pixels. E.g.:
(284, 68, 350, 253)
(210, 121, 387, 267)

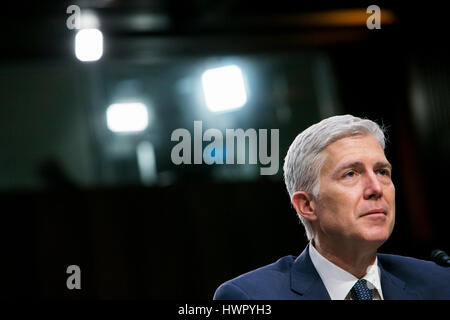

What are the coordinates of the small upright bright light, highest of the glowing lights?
(75, 29, 103, 61)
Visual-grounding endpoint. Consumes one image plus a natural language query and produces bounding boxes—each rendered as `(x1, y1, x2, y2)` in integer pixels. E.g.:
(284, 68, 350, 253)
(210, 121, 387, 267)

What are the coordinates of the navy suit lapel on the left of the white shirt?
(291, 244, 330, 300)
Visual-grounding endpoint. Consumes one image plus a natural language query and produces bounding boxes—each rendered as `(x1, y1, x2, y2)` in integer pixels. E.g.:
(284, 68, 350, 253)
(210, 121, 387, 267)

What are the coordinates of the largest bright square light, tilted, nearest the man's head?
(202, 65, 247, 112)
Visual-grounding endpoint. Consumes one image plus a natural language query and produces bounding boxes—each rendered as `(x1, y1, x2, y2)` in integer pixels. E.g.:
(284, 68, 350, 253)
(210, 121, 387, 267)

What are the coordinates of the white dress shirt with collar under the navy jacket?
(309, 241, 383, 300)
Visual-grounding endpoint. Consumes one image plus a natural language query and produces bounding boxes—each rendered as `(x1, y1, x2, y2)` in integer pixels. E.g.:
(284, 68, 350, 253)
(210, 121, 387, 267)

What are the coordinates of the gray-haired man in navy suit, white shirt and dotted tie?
(214, 115, 450, 300)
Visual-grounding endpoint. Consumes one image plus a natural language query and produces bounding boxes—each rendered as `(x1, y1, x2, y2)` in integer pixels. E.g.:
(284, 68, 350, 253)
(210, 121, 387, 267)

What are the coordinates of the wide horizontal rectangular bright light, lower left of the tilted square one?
(106, 103, 148, 132)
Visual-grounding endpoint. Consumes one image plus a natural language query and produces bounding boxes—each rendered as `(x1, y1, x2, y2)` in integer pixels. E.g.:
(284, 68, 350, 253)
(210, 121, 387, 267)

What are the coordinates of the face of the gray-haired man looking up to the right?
(314, 135, 395, 246)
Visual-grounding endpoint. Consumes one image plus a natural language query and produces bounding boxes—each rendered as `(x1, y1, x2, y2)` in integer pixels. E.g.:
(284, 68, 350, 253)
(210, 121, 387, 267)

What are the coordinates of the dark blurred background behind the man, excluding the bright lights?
(0, 0, 450, 299)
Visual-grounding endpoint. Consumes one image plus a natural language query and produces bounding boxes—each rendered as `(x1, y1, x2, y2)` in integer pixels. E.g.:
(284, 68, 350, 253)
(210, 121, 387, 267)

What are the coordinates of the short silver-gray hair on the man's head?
(283, 114, 385, 240)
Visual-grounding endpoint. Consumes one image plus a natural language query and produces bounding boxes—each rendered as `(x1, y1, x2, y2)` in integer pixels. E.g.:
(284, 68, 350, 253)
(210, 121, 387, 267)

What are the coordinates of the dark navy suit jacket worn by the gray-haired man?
(214, 247, 450, 300)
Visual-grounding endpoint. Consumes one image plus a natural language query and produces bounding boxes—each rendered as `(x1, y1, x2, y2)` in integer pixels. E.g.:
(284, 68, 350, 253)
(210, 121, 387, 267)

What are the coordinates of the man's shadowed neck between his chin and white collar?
(311, 239, 377, 279)
